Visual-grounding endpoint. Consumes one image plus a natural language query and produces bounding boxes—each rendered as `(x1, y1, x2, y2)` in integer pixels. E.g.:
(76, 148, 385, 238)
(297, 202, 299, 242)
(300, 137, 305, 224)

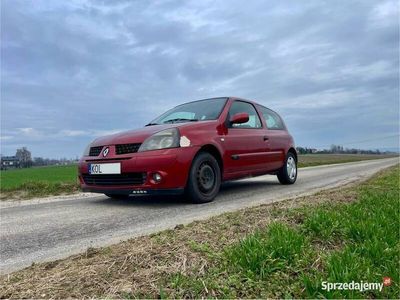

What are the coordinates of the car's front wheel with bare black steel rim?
(185, 152, 221, 204)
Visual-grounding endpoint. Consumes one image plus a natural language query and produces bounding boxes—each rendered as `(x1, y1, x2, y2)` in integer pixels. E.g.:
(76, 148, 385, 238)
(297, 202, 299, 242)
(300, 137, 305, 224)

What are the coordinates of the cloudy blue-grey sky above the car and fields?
(1, 0, 399, 158)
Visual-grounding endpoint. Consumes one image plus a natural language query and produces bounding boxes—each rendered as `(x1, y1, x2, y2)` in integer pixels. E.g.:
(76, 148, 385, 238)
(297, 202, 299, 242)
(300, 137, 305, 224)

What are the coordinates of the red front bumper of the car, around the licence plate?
(78, 146, 200, 195)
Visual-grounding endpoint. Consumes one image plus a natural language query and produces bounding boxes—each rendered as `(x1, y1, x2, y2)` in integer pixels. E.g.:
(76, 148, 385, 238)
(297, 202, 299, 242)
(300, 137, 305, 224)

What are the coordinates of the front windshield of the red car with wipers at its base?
(147, 98, 227, 125)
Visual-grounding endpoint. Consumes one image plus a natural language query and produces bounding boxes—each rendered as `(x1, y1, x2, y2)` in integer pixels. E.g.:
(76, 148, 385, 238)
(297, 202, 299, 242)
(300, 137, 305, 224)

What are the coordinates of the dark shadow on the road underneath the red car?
(93, 180, 280, 208)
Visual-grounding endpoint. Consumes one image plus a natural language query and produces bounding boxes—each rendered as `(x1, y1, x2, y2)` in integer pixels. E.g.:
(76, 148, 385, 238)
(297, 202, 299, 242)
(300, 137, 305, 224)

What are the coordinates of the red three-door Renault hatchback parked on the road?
(79, 97, 297, 203)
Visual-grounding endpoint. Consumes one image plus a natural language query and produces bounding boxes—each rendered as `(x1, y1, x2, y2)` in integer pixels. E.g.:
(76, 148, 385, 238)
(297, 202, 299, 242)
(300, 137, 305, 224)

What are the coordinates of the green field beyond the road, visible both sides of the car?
(0, 154, 394, 200)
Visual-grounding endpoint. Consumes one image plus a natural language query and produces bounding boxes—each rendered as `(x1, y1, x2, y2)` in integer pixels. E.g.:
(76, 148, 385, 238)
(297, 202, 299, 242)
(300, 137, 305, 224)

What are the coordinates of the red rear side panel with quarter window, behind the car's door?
(257, 105, 290, 171)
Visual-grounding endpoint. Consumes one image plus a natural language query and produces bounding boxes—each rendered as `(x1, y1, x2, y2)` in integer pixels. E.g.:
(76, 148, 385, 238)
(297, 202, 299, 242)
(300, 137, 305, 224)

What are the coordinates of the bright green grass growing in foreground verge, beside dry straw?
(167, 167, 400, 299)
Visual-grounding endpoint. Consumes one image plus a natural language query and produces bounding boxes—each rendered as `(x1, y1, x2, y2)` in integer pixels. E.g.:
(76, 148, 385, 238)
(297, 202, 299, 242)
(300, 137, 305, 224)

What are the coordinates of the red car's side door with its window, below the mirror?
(222, 100, 267, 177)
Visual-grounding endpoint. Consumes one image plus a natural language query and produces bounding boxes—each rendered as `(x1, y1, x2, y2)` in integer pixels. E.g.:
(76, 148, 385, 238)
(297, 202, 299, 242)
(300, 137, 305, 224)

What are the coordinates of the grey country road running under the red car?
(0, 158, 399, 274)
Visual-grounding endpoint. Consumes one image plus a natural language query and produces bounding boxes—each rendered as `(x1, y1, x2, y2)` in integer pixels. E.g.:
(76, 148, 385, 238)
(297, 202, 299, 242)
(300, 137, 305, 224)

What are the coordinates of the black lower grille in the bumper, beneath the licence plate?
(82, 173, 146, 185)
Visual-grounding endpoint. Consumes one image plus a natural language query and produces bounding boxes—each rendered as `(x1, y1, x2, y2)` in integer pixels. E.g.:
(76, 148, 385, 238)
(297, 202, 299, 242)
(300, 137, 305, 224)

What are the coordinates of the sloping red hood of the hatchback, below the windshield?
(91, 123, 187, 146)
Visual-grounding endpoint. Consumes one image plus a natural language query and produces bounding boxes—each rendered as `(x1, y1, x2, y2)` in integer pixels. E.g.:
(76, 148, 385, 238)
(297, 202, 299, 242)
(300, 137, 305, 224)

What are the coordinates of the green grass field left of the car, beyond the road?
(0, 165, 77, 199)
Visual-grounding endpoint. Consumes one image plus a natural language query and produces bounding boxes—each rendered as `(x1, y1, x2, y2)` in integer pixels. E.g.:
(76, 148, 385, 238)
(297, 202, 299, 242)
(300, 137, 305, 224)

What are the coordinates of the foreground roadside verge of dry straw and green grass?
(0, 165, 400, 299)
